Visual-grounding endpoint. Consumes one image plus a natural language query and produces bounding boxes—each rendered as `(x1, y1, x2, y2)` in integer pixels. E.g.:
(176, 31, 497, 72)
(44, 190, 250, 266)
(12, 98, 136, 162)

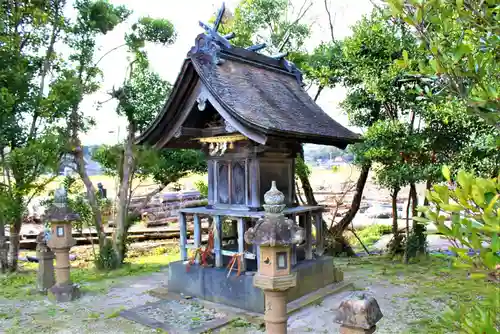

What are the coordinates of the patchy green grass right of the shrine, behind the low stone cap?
(336, 256, 500, 334)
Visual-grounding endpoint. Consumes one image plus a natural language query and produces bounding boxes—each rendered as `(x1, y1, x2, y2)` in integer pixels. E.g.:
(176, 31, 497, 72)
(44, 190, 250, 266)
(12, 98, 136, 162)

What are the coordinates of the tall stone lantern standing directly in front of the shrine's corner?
(245, 181, 304, 334)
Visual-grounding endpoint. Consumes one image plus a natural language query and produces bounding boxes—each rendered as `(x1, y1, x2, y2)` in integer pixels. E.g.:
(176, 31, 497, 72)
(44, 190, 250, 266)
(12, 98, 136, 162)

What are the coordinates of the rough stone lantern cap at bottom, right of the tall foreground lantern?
(335, 292, 383, 330)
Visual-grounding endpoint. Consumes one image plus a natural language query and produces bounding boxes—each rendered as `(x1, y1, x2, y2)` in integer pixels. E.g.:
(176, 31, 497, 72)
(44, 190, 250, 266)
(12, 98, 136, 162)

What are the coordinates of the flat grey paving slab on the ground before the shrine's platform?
(120, 300, 233, 334)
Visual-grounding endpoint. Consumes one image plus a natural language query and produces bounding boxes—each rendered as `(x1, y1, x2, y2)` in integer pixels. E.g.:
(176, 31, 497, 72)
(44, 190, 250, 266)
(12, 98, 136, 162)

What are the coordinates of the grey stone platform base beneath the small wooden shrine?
(168, 256, 343, 314)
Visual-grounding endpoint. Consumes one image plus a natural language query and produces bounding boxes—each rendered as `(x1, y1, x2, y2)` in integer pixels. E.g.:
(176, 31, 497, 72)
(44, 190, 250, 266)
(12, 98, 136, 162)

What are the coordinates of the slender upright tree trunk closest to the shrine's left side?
(114, 124, 135, 263)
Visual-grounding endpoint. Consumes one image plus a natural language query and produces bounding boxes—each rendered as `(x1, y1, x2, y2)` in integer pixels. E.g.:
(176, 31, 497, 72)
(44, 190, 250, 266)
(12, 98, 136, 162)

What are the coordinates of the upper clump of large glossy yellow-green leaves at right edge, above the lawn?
(419, 167, 500, 277)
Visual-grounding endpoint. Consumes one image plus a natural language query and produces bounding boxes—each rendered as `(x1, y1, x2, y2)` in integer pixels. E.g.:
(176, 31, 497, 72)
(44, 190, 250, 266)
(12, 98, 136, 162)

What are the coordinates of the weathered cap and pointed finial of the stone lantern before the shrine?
(245, 181, 304, 247)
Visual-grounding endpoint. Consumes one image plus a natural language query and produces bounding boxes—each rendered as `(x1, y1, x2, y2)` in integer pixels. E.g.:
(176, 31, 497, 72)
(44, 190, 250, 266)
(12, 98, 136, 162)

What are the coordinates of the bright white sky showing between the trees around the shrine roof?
(81, 0, 372, 145)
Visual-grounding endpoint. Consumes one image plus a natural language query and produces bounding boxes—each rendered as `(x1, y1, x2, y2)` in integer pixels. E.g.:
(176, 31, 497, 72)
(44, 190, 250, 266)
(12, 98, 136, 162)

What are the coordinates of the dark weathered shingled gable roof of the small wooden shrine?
(138, 5, 360, 148)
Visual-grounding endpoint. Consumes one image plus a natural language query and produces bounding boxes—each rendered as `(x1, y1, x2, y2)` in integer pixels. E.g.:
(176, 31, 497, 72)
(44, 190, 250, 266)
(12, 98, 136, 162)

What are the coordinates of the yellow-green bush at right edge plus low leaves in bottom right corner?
(414, 166, 500, 334)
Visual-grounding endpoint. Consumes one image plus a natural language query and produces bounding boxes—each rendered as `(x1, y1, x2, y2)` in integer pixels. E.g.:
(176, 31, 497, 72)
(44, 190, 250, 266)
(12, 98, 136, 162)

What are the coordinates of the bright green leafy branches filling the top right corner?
(388, 0, 500, 129)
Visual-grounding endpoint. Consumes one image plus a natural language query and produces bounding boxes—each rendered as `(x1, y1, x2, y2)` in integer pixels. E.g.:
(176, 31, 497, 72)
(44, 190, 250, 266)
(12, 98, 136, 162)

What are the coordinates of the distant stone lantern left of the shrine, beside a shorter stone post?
(47, 189, 80, 302)
